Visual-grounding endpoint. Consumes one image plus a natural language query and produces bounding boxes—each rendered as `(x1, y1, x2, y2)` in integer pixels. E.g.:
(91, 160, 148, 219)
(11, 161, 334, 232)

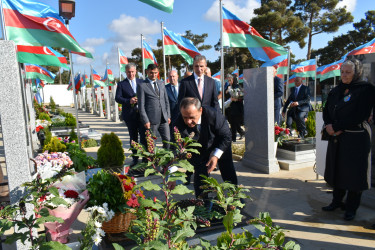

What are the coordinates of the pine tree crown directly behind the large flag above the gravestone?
(250, 0, 309, 48)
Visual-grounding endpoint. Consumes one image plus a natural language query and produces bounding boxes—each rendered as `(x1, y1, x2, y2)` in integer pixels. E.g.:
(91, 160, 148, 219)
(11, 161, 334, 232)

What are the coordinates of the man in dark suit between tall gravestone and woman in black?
(282, 77, 311, 138)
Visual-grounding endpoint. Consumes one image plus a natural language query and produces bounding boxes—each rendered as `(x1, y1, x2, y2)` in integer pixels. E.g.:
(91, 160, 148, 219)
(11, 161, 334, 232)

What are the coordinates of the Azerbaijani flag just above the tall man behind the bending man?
(163, 28, 200, 65)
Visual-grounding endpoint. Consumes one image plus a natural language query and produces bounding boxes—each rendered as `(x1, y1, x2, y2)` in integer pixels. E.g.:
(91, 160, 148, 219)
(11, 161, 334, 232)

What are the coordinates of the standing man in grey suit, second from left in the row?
(137, 64, 171, 148)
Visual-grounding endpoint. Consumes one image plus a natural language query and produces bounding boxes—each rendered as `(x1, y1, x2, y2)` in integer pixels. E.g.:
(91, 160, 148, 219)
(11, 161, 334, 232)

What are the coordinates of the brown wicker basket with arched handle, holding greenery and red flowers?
(102, 174, 137, 233)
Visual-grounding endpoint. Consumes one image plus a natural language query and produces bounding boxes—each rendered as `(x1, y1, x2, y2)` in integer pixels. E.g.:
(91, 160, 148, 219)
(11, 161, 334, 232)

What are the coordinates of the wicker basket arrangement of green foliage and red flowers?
(87, 170, 144, 233)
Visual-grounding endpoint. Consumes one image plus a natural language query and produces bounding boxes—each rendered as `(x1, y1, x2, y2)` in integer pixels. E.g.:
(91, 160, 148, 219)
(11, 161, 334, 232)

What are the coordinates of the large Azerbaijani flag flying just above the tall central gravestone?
(223, 7, 288, 63)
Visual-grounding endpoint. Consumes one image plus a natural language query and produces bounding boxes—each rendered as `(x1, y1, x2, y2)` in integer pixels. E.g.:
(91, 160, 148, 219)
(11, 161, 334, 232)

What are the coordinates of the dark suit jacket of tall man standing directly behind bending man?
(178, 74, 220, 110)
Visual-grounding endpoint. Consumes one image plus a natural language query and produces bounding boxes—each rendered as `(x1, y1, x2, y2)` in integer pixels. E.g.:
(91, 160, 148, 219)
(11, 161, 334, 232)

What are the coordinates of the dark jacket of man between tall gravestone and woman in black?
(283, 84, 311, 113)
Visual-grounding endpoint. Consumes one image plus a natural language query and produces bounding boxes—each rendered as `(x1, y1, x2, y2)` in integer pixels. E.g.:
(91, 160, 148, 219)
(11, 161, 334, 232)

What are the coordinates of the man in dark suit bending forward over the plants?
(176, 97, 238, 197)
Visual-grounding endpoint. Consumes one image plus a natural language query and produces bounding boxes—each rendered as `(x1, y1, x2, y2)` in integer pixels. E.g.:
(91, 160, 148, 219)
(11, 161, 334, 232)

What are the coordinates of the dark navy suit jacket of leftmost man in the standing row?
(115, 78, 142, 121)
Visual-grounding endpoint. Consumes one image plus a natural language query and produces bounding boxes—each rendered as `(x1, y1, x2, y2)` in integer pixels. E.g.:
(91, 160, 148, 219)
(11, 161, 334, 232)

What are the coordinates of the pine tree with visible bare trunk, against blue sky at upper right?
(294, 0, 353, 60)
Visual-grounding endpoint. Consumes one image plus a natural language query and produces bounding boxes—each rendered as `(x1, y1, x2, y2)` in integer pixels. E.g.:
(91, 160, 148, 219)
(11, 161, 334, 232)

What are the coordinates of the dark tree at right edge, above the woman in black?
(311, 10, 375, 65)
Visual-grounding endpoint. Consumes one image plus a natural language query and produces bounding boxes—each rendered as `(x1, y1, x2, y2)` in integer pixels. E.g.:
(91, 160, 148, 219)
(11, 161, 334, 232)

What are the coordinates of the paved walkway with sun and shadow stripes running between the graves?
(67, 110, 375, 250)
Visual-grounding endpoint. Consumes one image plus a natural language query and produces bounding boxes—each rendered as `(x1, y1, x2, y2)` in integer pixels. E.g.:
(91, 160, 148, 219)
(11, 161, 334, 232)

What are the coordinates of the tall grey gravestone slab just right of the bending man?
(242, 67, 279, 174)
